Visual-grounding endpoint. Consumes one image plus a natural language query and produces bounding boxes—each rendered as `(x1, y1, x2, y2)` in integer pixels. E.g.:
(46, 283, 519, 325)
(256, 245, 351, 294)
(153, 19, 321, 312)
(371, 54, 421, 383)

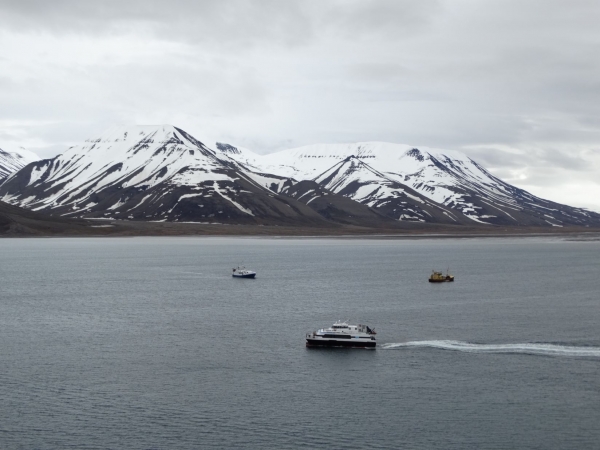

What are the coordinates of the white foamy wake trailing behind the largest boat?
(381, 340, 600, 358)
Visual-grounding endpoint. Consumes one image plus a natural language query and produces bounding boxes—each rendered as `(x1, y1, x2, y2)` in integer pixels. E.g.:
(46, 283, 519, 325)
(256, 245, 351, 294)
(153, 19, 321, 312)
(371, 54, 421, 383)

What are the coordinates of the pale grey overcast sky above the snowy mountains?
(0, 0, 600, 211)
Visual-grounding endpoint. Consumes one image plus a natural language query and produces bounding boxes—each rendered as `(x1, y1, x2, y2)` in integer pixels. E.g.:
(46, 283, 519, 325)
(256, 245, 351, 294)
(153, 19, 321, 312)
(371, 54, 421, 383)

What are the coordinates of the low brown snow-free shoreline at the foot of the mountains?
(0, 202, 600, 240)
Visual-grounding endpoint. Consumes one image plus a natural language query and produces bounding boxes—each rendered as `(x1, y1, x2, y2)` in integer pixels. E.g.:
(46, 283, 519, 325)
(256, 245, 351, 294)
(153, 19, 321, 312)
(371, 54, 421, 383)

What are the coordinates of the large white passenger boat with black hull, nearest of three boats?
(306, 322, 376, 347)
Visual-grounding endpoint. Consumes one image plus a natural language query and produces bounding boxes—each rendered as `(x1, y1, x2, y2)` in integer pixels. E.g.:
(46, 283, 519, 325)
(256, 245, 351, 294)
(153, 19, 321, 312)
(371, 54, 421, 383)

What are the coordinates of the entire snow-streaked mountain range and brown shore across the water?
(0, 125, 600, 235)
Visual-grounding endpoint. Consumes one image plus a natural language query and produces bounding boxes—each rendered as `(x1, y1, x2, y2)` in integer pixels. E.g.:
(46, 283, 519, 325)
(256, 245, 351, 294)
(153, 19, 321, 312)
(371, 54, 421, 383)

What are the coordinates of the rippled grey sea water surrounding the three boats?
(0, 238, 600, 449)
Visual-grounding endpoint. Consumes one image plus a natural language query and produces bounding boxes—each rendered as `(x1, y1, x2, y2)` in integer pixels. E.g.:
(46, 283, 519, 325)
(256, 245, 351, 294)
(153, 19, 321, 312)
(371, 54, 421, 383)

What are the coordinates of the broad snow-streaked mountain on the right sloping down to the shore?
(220, 142, 600, 227)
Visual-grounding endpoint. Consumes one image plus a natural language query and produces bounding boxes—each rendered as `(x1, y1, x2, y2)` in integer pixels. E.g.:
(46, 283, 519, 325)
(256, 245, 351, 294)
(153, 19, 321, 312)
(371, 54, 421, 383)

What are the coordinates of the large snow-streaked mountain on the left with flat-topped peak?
(0, 125, 332, 224)
